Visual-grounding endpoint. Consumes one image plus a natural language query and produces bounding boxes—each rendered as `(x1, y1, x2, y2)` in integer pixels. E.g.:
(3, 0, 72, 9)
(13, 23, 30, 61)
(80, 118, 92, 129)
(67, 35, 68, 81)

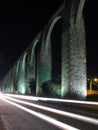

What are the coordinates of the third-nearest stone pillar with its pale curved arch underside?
(27, 39, 39, 94)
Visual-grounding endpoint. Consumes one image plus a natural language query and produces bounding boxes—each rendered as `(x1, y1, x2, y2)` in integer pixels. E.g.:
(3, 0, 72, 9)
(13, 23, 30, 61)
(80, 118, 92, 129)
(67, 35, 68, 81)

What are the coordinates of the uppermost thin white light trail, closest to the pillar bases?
(5, 94, 98, 105)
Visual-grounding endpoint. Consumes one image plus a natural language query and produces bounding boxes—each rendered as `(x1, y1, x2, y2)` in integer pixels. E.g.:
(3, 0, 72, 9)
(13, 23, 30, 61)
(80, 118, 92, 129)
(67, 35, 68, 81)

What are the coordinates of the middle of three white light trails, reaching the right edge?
(4, 96, 98, 125)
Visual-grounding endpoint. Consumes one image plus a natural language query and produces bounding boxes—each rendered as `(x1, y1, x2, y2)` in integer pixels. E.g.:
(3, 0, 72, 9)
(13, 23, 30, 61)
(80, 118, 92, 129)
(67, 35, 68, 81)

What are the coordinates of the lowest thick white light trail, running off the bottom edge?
(1, 97, 79, 130)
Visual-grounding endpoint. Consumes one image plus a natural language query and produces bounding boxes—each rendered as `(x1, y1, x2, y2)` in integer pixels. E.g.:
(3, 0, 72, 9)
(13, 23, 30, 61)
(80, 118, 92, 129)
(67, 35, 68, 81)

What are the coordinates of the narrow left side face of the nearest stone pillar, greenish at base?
(61, 0, 71, 98)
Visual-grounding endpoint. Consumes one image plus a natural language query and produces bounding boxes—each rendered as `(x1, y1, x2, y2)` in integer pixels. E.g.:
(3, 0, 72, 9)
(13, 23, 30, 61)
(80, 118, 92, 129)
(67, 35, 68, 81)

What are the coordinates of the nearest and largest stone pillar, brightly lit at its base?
(61, 0, 86, 99)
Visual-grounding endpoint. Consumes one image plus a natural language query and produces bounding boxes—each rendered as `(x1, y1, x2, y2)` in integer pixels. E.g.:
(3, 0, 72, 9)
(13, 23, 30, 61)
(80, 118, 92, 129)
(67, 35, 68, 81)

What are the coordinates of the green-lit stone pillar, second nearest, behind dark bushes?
(36, 29, 51, 96)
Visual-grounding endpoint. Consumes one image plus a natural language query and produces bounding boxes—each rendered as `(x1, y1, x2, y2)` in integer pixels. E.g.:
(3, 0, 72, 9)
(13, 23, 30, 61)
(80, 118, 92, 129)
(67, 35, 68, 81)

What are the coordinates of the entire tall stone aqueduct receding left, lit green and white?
(1, 0, 87, 99)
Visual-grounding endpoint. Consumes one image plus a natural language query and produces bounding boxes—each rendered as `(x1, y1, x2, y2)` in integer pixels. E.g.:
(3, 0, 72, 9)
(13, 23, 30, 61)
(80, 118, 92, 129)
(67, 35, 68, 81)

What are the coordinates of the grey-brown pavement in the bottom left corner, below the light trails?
(0, 99, 58, 130)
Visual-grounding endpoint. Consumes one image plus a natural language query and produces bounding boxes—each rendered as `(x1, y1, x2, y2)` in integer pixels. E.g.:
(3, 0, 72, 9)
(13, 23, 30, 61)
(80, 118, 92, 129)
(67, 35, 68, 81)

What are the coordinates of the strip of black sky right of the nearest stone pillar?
(84, 0, 98, 75)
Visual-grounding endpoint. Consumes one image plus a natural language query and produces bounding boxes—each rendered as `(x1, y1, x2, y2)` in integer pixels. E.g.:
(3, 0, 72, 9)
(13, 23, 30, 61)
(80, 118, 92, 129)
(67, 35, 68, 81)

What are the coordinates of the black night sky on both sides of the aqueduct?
(0, 0, 98, 78)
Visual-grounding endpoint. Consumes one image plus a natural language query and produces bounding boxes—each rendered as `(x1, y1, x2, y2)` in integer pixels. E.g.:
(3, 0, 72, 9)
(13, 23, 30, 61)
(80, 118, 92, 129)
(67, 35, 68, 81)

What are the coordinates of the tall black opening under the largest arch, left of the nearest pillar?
(50, 19, 62, 84)
